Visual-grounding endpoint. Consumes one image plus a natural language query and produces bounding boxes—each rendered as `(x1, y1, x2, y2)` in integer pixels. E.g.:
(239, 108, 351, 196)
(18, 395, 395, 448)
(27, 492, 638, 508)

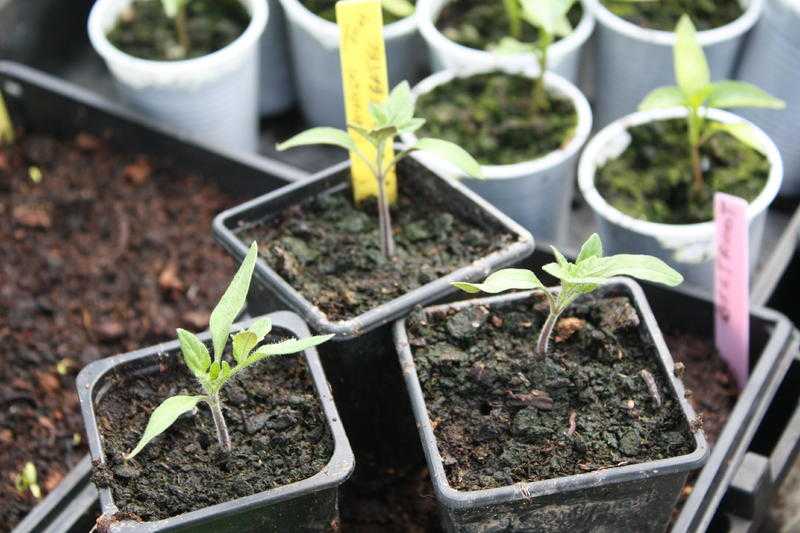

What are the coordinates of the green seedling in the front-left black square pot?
(125, 242, 333, 459)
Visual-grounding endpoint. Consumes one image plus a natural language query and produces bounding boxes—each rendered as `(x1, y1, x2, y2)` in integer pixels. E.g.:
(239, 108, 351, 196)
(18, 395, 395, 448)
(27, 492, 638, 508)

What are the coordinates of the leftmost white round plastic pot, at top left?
(88, 0, 268, 151)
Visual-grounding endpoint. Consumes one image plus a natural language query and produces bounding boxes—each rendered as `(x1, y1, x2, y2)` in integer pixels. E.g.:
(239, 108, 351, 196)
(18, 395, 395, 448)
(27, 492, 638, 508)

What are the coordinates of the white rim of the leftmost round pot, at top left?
(87, 0, 269, 87)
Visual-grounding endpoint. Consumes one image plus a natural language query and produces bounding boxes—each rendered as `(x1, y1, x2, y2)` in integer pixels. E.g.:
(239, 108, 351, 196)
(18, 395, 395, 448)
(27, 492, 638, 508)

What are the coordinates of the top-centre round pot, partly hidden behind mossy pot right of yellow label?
(417, 0, 594, 83)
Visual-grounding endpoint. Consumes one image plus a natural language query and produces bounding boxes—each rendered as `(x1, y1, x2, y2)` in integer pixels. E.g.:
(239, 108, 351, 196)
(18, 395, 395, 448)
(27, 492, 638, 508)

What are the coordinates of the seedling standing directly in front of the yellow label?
(278, 81, 483, 259)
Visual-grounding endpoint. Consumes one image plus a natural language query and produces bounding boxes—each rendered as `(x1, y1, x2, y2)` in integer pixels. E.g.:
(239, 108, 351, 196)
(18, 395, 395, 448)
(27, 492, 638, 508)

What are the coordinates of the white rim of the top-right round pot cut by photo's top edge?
(584, 0, 765, 48)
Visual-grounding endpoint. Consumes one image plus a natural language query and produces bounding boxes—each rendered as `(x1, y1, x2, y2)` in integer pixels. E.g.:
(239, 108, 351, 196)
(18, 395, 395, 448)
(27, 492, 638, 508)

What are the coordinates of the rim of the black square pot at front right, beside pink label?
(393, 278, 709, 509)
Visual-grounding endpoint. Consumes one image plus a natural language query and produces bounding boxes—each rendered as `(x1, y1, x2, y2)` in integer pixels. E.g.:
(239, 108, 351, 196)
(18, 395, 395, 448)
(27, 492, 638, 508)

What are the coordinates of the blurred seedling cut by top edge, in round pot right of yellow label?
(494, 0, 575, 111)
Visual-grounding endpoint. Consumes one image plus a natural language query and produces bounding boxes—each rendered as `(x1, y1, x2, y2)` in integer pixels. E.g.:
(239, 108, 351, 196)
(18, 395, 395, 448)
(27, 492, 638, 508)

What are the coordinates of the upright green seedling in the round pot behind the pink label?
(639, 15, 786, 195)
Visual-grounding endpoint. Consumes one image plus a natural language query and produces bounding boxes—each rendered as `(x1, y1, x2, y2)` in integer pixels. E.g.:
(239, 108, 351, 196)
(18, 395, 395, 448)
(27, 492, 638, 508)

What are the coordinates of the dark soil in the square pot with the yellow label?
(239, 159, 516, 320)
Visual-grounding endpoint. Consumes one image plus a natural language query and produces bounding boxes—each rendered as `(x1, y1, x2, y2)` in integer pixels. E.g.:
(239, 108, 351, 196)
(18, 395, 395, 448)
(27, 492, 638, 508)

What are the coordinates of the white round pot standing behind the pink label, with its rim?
(578, 108, 783, 293)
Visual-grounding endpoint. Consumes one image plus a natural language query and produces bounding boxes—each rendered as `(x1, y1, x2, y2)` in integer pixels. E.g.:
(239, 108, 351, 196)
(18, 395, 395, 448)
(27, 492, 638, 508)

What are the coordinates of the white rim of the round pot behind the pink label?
(578, 107, 783, 242)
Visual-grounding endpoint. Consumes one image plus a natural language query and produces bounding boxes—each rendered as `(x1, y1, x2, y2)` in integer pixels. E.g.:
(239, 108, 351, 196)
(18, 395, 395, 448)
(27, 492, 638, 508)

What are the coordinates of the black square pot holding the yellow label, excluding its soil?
(214, 159, 534, 481)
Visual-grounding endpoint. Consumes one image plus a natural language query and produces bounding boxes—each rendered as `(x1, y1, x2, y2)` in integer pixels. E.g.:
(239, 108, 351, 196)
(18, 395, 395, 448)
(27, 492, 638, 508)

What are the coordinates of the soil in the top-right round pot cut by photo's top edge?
(601, 0, 744, 31)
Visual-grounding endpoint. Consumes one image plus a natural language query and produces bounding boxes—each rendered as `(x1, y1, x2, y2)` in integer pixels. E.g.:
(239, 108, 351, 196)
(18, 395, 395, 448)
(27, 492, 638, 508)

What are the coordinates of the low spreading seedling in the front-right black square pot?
(453, 233, 683, 357)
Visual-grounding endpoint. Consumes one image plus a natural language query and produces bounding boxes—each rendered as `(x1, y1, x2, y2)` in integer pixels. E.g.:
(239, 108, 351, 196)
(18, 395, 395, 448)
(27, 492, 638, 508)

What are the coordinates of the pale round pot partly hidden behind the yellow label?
(280, 0, 423, 128)
